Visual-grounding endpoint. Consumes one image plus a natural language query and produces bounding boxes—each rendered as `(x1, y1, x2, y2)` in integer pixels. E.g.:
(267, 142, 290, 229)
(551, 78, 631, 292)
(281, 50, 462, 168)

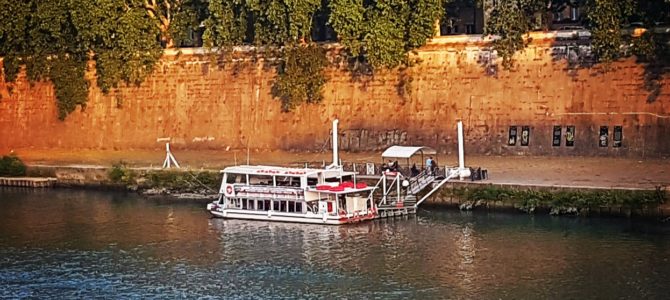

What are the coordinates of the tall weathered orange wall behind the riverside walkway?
(0, 37, 670, 157)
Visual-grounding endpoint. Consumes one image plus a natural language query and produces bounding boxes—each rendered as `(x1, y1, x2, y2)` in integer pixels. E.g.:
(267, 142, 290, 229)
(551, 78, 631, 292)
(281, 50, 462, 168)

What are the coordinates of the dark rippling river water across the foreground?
(0, 188, 670, 299)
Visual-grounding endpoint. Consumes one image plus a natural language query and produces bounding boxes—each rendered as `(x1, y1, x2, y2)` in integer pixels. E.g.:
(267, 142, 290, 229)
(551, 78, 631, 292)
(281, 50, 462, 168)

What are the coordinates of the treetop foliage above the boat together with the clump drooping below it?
(203, 0, 328, 111)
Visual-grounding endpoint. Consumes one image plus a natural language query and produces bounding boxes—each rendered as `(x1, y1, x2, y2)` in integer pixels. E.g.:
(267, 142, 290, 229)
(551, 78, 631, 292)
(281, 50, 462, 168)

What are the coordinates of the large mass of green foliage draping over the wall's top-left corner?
(0, 0, 162, 119)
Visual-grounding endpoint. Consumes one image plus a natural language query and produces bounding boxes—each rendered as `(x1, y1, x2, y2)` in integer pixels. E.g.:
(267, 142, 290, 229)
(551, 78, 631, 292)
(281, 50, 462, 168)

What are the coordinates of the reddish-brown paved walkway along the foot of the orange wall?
(10, 149, 670, 190)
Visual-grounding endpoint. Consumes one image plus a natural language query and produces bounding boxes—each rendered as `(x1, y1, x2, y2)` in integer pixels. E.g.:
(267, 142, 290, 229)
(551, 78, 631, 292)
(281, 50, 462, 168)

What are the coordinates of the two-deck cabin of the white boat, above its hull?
(218, 165, 374, 218)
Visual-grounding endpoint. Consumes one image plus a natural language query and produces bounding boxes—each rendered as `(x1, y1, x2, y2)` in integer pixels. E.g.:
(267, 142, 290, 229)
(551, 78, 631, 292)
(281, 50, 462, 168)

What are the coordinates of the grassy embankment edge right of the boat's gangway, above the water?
(425, 181, 670, 219)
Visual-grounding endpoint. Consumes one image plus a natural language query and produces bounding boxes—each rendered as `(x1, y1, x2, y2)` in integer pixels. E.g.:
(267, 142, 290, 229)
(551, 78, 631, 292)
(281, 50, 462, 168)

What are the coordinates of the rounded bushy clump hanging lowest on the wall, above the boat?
(274, 45, 328, 111)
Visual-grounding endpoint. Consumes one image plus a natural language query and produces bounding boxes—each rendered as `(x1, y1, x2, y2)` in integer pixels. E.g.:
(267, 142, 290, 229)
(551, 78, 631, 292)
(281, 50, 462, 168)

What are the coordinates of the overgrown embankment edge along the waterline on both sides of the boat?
(18, 165, 670, 219)
